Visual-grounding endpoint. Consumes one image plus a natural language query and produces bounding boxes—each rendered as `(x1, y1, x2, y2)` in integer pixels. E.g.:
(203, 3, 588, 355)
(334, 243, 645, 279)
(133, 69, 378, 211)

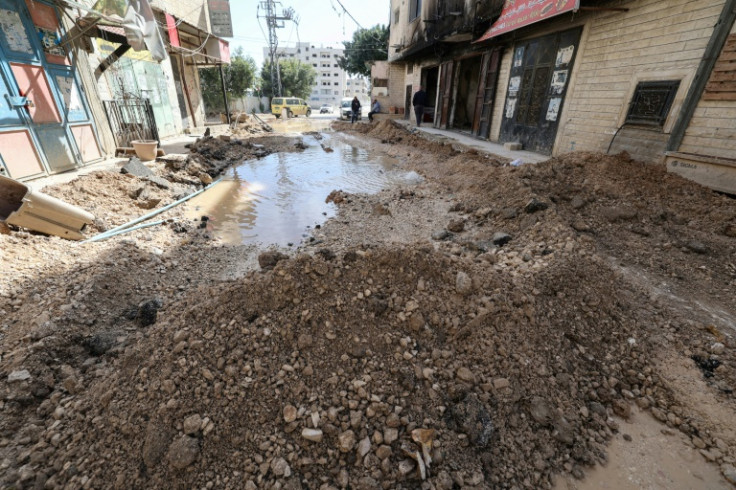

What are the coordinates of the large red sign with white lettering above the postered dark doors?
(475, 0, 580, 43)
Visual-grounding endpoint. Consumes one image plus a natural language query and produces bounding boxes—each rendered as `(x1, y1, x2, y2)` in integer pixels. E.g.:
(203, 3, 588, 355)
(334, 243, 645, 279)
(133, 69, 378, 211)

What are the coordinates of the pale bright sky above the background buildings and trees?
(228, 0, 391, 67)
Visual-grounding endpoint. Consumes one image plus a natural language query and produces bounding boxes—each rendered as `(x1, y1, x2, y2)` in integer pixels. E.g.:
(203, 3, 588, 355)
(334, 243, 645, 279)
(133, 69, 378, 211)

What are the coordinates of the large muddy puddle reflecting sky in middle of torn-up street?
(187, 135, 420, 246)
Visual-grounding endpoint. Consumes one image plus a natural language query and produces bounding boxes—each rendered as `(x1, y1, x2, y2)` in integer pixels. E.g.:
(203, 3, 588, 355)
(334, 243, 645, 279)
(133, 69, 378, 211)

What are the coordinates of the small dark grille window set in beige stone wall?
(626, 80, 680, 127)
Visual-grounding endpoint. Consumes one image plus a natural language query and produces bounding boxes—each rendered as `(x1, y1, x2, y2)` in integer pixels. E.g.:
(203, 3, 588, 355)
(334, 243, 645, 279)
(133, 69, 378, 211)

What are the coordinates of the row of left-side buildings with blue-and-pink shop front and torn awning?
(0, 0, 229, 180)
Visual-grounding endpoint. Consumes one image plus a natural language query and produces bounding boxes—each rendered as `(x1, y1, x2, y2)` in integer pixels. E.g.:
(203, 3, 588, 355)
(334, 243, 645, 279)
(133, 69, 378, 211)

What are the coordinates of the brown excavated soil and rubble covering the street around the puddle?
(0, 121, 736, 489)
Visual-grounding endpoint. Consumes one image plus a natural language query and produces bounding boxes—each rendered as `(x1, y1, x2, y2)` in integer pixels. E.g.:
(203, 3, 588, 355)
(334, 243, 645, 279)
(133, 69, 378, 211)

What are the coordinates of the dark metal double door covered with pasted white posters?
(501, 28, 582, 155)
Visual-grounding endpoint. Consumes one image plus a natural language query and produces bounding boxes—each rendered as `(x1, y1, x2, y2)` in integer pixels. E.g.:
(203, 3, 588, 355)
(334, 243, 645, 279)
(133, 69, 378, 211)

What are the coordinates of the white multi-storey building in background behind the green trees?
(263, 43, 346, 109)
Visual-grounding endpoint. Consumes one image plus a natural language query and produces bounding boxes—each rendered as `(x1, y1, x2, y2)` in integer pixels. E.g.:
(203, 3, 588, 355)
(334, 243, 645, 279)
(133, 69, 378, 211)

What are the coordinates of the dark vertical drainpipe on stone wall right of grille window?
(666, 0, 736, 151)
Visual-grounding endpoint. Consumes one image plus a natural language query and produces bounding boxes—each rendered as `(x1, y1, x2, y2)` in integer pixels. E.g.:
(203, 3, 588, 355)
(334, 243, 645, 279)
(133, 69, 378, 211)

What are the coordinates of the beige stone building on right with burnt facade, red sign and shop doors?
(382, 0, 736, 193)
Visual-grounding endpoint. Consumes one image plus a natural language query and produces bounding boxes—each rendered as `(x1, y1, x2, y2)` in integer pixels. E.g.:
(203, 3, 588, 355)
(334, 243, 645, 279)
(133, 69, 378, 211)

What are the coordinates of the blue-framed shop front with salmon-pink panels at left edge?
(0, 0, 102, 180)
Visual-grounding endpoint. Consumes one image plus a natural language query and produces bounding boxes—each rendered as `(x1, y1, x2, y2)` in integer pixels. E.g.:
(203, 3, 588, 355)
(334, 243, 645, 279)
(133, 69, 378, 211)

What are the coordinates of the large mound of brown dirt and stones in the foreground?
(4, 243, 732, 488)
